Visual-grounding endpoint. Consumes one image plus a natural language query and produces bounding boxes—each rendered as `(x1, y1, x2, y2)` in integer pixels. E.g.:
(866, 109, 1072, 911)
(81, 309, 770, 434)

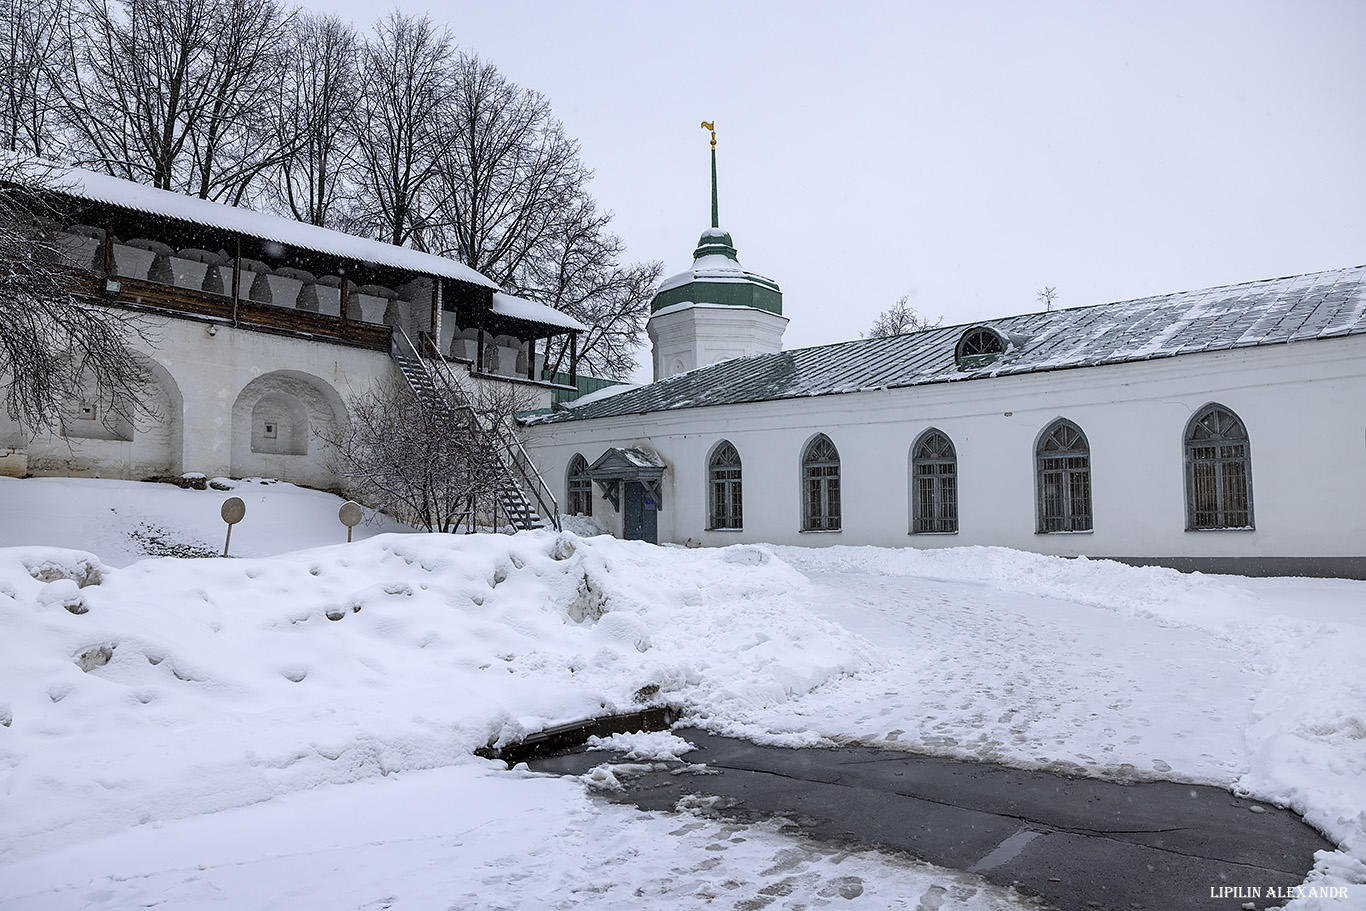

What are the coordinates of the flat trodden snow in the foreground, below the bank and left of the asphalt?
(0, 768, 1030, 911)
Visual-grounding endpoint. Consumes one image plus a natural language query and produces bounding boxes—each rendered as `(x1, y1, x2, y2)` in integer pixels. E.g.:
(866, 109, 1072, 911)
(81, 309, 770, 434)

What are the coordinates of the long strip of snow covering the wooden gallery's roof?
(20, 164, 502, 288)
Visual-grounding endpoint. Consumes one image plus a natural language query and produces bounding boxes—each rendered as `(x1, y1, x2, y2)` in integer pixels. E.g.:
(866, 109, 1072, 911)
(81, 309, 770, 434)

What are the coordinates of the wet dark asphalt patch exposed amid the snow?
(529, 731, 1333, 911)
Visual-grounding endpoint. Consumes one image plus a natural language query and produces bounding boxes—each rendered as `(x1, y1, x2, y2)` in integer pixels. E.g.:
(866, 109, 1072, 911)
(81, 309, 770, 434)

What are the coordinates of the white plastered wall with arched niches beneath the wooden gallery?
(9, 313, 550, 488)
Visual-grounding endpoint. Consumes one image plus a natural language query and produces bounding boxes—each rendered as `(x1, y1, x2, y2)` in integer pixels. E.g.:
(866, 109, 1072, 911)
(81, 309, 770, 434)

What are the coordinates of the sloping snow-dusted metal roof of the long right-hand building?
(529, 266, 1366, 423)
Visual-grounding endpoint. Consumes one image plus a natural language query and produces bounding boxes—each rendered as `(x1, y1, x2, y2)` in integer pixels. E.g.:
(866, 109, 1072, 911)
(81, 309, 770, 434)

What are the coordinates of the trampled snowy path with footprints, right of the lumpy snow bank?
(765, 572, 1265, 785)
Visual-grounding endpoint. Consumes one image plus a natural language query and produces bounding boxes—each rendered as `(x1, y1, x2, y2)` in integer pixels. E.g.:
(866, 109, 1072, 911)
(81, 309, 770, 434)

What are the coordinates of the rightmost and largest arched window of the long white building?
(1186, 404, 1253, 529)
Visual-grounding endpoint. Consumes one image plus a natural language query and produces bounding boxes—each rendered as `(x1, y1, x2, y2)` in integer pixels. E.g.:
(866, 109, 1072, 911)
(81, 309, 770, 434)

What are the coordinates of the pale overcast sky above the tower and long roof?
(305, 0, 1366, 374)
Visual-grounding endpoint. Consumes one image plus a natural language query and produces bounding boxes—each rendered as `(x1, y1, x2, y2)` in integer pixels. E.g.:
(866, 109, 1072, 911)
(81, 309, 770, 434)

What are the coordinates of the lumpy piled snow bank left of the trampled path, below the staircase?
(0, 533, 872, 860)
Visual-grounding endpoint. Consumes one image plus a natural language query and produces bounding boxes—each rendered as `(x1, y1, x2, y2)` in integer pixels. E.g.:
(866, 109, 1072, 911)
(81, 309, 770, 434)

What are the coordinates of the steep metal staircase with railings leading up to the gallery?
(389, 326, 560, 531)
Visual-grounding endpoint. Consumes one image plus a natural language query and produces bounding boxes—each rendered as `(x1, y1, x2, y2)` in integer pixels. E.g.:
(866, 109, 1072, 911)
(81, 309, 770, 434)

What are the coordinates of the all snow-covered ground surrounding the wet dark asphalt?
(0, 479, 1366, 911)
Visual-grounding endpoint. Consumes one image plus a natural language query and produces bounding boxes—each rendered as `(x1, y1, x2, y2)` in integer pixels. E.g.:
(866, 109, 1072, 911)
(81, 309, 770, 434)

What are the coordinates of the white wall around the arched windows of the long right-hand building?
(527, 337, 1366, 557)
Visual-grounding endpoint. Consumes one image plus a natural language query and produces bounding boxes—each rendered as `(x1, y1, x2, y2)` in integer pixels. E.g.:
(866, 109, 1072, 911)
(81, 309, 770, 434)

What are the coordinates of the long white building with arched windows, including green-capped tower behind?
(526, 148, 1366, 578)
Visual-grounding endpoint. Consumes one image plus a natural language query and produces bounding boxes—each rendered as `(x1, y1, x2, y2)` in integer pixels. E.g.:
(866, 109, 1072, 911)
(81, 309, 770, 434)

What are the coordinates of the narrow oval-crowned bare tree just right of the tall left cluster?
(272, 15, 359, 227)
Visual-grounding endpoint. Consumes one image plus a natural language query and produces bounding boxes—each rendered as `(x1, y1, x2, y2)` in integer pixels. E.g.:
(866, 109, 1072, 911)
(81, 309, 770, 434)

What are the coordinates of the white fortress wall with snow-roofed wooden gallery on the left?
(0, 158, 585, 524)
